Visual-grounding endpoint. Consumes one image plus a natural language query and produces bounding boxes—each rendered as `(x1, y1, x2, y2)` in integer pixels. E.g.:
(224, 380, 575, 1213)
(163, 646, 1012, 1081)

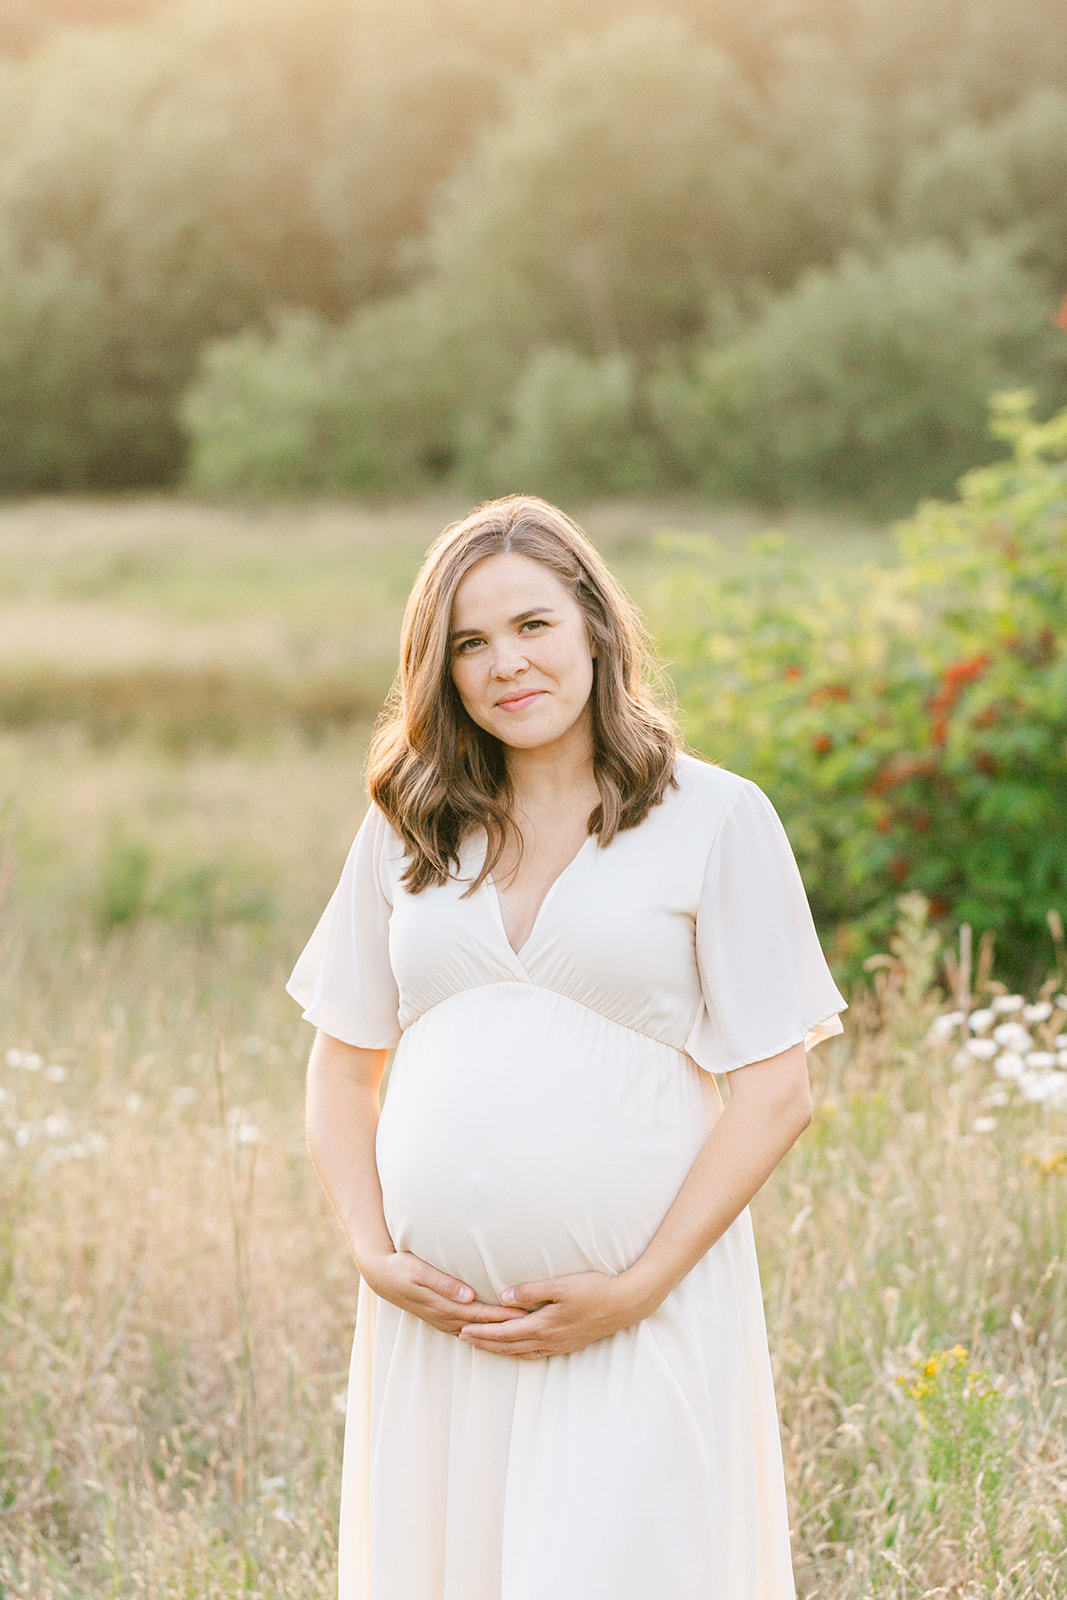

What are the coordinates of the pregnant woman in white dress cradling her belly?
(290, 496, 845, 1600)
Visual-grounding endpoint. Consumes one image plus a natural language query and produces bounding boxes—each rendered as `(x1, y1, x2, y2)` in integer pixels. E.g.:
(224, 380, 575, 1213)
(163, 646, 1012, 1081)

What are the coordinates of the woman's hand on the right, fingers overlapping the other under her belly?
(459, 1272, 648, 1360)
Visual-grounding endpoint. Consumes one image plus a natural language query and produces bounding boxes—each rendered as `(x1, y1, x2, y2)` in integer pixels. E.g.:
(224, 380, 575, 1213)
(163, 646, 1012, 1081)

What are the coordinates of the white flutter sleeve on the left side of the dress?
(285, 806, 402, 1050)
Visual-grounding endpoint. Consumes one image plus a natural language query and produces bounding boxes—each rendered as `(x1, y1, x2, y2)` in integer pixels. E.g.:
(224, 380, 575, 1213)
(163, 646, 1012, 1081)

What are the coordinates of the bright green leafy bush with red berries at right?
(661, 395, 1067, 976)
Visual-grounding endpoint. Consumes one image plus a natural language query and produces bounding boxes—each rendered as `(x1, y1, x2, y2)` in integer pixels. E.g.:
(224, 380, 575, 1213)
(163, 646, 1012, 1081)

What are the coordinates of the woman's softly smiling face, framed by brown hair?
(450, 552, 593, 750)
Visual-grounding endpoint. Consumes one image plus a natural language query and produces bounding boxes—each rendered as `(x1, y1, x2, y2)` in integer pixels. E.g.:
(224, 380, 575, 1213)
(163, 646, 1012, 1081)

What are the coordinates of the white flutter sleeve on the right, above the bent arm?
(686, 781, 845, 1072)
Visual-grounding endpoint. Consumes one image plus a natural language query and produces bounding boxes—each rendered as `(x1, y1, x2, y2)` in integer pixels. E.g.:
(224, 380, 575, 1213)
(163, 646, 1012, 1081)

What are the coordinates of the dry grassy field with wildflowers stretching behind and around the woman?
(0, 502, 1067, 1600)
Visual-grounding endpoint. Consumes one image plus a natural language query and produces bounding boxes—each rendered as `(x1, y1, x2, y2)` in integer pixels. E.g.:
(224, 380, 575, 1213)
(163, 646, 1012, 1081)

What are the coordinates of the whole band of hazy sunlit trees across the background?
(0, 0, 1067, 509)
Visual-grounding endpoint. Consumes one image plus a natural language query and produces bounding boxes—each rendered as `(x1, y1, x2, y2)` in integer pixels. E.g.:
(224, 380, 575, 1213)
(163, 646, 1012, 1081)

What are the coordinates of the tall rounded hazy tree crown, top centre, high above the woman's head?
(430, 16, 792, 357)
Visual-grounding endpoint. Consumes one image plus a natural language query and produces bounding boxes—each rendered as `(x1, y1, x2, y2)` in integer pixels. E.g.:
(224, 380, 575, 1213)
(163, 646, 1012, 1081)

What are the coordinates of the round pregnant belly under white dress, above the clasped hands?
(378, 984, 718, 1301)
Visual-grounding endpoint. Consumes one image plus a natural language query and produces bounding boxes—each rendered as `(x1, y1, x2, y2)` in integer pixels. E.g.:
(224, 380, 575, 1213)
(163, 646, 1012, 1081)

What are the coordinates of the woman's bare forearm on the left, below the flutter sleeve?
(307, 1032, 394, 1270)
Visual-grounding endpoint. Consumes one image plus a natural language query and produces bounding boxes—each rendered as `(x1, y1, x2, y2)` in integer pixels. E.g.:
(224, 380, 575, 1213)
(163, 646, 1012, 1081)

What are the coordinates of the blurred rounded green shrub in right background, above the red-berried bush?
(649, 240, 1067, 509)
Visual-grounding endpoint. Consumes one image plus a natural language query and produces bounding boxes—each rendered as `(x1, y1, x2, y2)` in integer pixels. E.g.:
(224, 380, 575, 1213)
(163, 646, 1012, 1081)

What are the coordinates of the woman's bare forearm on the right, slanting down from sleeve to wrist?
(622, 1045, 811, 1315)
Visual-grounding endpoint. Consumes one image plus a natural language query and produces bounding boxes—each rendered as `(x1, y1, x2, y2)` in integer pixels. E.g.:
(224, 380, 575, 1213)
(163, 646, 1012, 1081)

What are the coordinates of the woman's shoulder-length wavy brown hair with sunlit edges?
(366, 494, 678, 894)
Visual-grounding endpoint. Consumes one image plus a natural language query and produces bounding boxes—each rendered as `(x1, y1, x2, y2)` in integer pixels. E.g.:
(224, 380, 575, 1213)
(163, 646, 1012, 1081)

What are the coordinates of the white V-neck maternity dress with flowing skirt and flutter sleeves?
(288, 755, 845, 1600)
